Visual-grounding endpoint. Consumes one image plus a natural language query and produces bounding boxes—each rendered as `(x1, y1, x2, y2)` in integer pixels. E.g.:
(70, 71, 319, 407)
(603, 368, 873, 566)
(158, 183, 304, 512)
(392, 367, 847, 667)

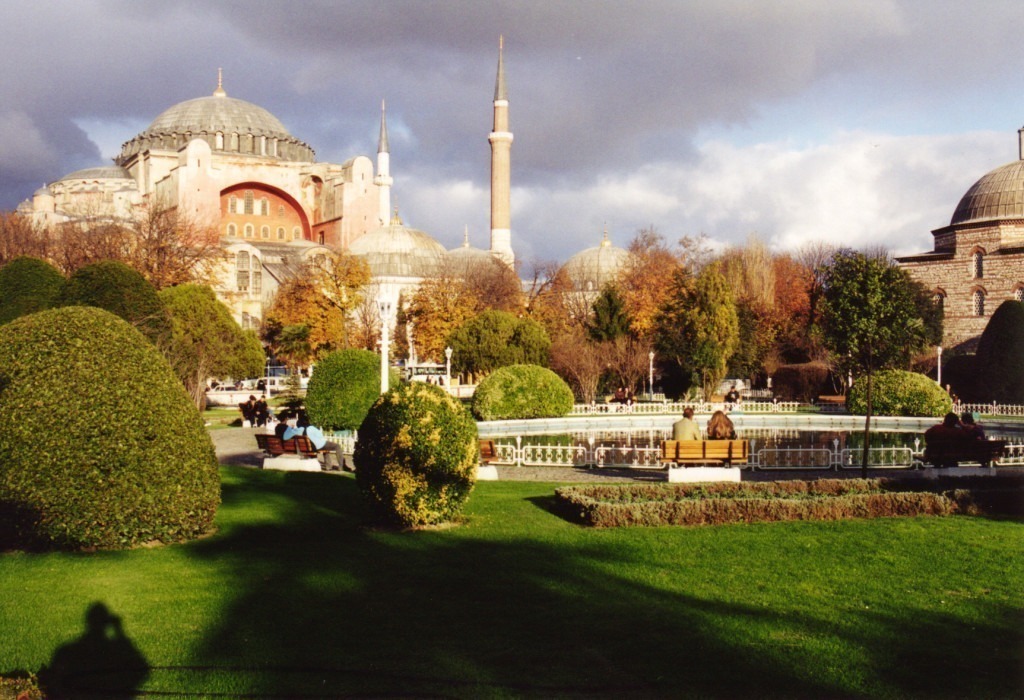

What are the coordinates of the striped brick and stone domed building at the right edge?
(898, 124, 1024, 350)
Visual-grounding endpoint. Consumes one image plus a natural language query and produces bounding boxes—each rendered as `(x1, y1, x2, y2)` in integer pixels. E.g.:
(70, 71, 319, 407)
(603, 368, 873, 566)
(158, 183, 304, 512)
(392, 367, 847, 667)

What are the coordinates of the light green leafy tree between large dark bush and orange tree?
(160, 285, 266, 410)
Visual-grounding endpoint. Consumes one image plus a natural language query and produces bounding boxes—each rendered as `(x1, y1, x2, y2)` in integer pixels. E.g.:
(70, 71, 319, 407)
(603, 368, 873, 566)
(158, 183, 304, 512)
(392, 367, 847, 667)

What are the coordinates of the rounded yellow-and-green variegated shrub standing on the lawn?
(353, 382, 479, 527)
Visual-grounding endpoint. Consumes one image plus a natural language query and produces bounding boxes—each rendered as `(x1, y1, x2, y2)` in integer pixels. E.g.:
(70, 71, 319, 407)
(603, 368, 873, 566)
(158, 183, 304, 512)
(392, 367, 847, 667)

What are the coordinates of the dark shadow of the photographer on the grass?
(39, 602, 150, 698)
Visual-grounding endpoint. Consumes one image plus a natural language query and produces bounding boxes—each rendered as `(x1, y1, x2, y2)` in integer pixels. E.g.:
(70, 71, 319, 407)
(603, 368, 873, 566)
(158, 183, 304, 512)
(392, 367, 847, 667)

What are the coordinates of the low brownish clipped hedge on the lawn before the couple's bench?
(555, 479, 972, 527)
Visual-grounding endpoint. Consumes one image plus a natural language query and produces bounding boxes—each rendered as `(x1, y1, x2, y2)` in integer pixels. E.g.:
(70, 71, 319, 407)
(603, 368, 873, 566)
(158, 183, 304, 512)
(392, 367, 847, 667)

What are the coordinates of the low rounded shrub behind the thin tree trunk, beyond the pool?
(846, 369, 953, 417)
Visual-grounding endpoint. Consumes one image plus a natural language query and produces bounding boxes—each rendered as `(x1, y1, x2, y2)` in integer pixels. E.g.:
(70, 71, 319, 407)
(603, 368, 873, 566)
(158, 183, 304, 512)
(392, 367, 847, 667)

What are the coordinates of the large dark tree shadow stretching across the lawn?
(165, 473, 1015, 698)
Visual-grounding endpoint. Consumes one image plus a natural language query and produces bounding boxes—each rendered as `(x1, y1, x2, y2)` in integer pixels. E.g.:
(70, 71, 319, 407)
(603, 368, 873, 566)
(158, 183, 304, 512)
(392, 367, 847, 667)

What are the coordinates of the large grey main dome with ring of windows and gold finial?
(116, 76, 315, 165)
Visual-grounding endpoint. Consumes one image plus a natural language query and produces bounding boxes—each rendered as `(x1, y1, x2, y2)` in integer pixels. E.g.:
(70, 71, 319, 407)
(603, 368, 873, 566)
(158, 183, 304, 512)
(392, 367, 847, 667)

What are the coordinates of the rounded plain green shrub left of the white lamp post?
(306, 350, 398, 430)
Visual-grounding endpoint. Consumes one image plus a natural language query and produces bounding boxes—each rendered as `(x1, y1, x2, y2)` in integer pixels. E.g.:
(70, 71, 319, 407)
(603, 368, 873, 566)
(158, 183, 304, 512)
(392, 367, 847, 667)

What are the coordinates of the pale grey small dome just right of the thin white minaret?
(348, 215, 446, 279)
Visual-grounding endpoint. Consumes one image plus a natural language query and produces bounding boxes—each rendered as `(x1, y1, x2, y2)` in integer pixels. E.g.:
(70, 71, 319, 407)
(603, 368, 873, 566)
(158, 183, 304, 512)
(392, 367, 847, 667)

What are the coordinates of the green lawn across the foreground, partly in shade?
(0, 467, 1024, 698)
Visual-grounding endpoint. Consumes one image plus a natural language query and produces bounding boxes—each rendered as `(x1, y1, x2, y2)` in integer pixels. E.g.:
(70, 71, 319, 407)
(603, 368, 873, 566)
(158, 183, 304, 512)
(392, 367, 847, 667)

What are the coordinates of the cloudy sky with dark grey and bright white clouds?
(0, 0, 1024, 263)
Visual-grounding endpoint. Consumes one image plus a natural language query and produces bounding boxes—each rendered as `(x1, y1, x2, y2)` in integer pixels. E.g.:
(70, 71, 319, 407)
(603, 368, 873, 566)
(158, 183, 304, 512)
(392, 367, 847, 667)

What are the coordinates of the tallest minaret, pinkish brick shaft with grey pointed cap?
(487, 37, 515, 266)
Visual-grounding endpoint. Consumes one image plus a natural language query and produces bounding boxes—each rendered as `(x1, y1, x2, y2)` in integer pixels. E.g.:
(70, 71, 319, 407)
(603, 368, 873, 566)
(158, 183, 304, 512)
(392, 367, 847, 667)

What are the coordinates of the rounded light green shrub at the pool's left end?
(473, 364, 573, 421)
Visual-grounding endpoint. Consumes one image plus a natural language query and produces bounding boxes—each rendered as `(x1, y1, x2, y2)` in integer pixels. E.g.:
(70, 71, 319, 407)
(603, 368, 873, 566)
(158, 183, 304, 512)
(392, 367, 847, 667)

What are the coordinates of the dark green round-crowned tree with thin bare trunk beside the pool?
(821, 250, 927, 478)
